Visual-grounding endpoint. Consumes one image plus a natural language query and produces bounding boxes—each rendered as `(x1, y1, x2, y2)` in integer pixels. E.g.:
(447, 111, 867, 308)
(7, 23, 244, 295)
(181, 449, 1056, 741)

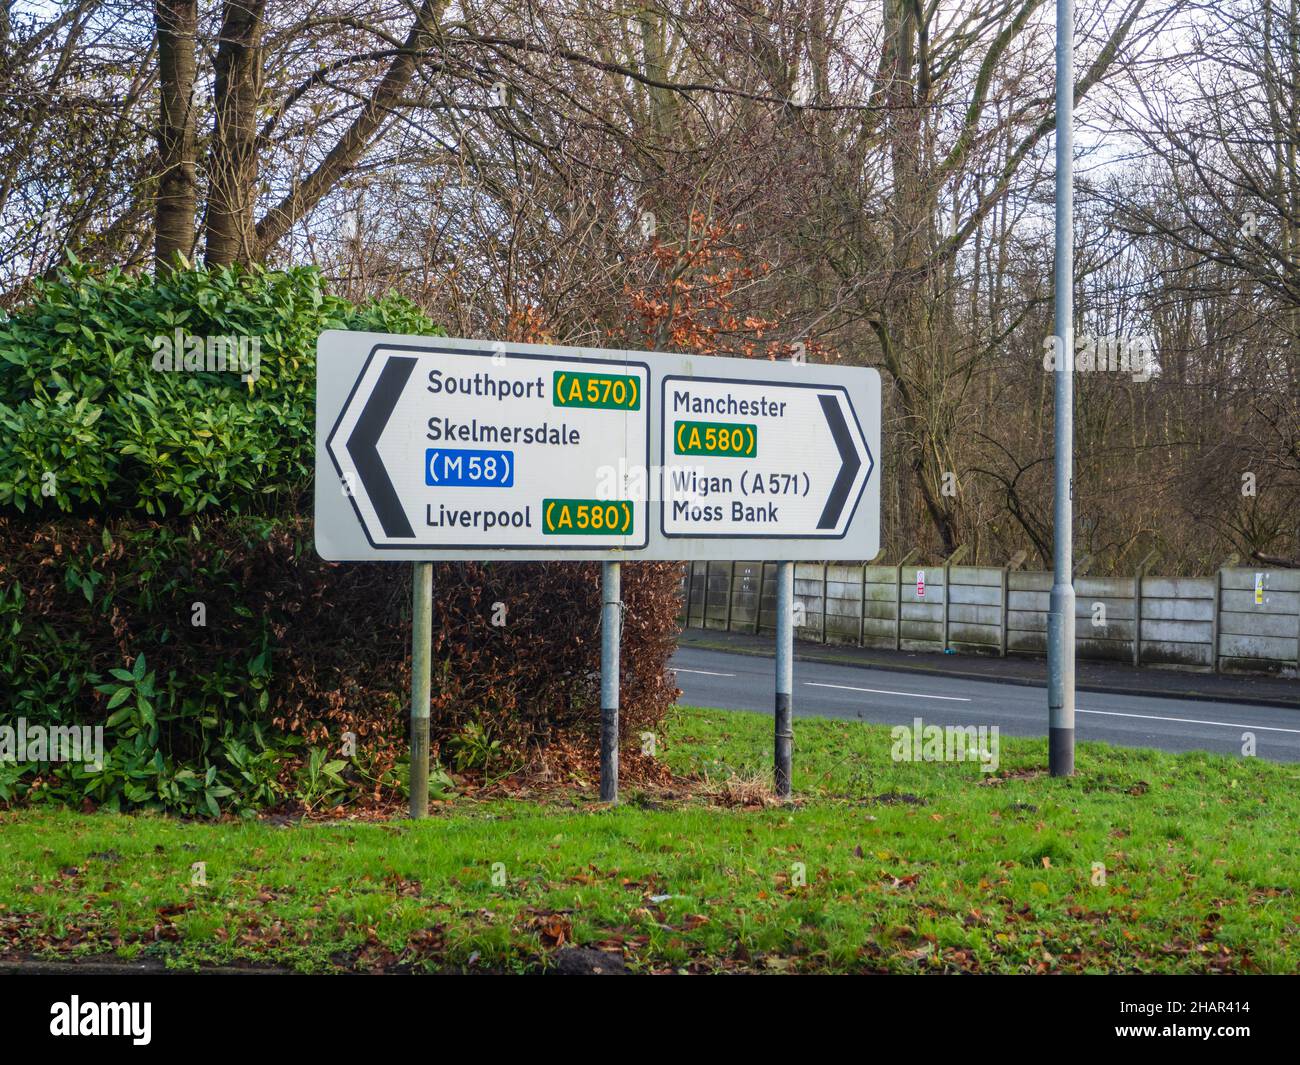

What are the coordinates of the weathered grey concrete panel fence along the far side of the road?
(683, 562, 1300, 672)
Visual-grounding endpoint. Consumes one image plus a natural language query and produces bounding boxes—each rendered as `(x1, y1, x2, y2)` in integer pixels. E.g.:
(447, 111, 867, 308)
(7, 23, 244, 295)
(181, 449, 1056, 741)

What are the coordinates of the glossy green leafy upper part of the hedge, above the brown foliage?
(0, 264, 442, 516)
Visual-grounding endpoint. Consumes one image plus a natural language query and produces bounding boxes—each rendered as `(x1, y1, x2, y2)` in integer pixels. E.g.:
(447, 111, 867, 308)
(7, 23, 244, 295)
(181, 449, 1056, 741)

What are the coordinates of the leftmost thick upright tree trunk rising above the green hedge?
(153, 0, 199, 270)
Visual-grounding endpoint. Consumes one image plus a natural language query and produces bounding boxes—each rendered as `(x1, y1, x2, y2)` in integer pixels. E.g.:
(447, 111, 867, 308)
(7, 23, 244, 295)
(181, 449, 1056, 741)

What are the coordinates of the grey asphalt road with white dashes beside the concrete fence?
(672, 648, 1300, 762)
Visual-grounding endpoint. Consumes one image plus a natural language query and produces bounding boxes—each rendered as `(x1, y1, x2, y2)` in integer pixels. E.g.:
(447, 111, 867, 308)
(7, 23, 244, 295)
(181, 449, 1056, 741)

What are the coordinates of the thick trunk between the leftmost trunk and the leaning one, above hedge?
(204, 0, 267, 267)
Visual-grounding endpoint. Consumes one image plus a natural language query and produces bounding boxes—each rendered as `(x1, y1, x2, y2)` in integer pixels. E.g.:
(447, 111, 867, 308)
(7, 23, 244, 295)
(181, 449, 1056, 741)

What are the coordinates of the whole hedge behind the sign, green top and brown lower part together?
(0, 267, 679, 815)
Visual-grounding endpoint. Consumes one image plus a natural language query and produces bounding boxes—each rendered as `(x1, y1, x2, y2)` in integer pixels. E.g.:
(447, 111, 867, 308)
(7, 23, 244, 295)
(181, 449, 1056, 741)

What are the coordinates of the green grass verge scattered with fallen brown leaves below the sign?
(0, 709, 1300, 973)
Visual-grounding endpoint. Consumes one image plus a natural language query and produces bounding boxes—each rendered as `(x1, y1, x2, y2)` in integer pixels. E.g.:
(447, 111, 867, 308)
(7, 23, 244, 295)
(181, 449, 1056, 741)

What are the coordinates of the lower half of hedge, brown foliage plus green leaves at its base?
(0, 518, 679, 814)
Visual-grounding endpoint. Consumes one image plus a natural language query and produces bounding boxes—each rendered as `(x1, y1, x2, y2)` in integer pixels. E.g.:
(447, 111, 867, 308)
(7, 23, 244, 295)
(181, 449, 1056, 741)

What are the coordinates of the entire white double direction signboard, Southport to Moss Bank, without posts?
(316, 332, 880, 562)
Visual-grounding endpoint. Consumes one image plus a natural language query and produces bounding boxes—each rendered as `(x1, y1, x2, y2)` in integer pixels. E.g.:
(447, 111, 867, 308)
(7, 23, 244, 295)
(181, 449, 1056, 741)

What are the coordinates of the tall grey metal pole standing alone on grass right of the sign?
(1048, 0, 1075, 776)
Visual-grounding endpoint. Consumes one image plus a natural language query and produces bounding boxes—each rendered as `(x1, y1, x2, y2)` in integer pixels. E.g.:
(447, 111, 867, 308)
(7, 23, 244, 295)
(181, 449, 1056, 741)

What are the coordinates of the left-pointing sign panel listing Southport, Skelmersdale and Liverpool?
(325, 345, 650, 550)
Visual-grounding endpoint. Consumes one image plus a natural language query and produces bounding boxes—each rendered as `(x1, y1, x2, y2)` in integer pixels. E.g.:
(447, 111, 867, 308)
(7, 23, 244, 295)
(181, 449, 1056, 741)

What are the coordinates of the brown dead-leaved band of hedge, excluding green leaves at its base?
(0, 515, 680, 802)
